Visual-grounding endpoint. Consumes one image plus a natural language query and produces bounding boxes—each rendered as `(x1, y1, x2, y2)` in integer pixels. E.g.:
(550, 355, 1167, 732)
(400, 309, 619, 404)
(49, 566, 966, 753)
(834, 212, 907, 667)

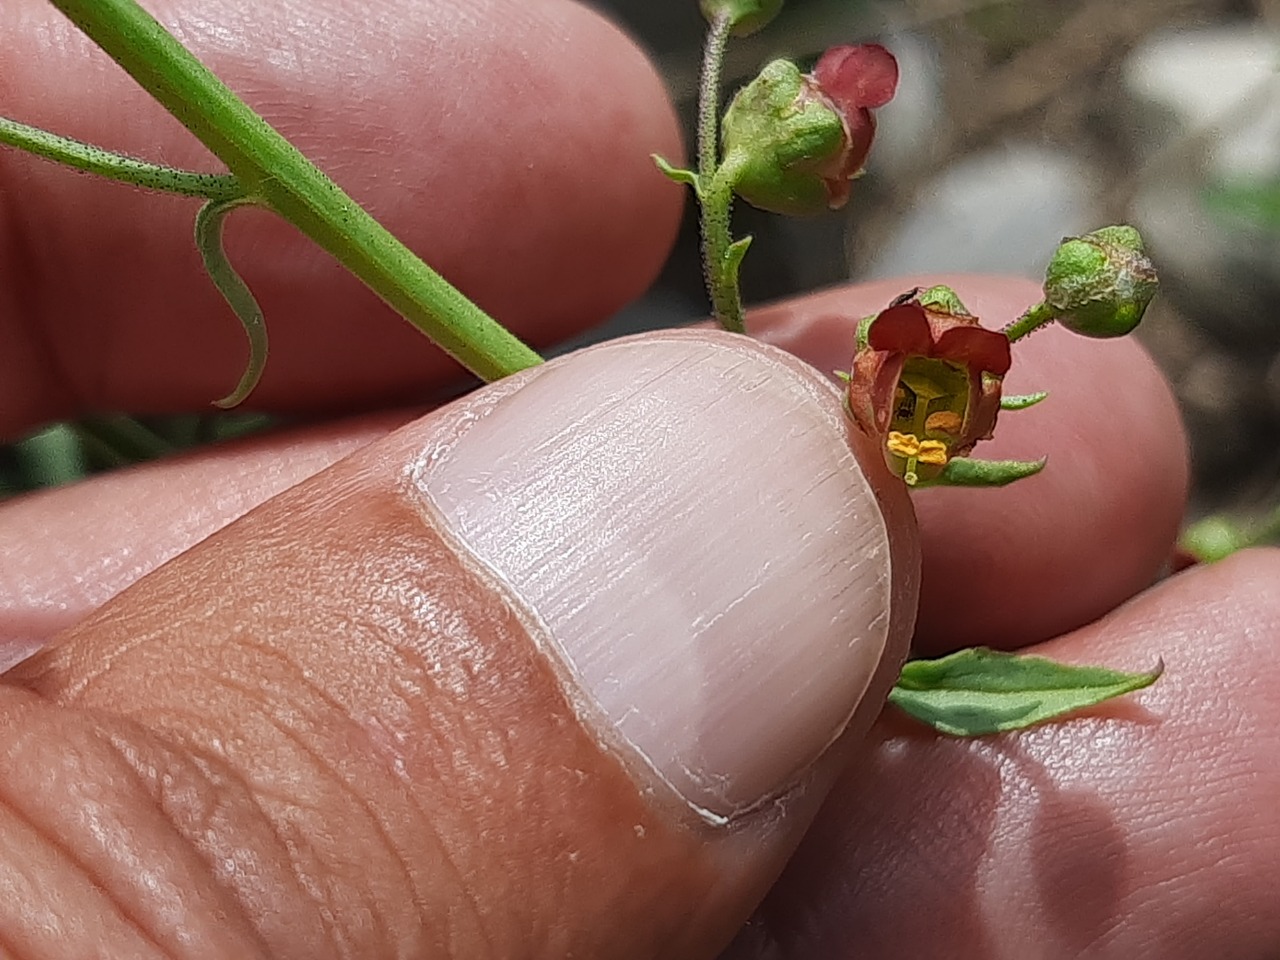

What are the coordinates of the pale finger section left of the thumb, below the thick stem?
(0, 411, 411, 671)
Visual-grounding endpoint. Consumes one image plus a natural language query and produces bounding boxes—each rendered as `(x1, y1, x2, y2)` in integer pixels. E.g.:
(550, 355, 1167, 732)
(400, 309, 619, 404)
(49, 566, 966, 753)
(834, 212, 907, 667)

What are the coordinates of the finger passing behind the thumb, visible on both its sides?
(0, 276, 1187, 655)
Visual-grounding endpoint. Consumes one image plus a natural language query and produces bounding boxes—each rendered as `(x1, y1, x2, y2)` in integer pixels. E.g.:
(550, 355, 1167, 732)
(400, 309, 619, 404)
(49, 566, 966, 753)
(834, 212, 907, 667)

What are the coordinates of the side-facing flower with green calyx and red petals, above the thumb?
(722, 44, 897, 216)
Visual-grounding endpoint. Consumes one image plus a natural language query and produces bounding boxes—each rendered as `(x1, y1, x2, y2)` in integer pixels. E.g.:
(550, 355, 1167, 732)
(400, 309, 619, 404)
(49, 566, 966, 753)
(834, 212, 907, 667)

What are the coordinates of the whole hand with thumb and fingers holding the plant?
(0, 1, 1280, 957)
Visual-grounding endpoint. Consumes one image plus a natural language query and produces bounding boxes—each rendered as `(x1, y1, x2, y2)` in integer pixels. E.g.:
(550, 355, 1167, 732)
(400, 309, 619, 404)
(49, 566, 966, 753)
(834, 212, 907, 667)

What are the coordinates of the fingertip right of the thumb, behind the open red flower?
(751, 276, 1188, 654)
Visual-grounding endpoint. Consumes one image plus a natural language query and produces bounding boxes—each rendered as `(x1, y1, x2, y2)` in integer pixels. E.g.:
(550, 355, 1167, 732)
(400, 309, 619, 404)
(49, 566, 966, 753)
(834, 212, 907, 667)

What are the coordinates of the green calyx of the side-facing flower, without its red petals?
(722, 60, 846, 216)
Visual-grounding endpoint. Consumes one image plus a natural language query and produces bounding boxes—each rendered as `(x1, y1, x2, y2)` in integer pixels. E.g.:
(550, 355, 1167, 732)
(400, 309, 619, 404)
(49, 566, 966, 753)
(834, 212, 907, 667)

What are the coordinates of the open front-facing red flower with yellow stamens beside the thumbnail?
(847, 287, 1011, 486)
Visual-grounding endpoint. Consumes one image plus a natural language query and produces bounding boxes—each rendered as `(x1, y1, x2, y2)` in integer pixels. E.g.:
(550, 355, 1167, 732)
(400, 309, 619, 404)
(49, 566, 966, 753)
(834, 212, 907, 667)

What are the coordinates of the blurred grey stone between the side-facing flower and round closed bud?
(861, 145, 1100, 279)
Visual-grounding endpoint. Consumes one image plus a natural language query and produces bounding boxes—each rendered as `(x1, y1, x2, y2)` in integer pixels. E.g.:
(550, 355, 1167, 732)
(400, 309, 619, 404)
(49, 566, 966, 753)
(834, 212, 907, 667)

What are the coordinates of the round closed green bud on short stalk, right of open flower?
(1044, 225, 1158, 337)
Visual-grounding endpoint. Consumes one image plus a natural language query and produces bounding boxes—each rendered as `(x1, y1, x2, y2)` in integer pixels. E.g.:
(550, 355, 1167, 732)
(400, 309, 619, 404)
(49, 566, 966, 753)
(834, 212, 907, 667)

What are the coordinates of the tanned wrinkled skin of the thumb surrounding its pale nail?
(0, 334, 918, 959)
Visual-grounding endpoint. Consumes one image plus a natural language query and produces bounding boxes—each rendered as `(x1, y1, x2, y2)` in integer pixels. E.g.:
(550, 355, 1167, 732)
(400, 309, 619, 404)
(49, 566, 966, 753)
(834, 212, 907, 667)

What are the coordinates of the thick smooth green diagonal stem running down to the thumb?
(51, 0, 541, 380)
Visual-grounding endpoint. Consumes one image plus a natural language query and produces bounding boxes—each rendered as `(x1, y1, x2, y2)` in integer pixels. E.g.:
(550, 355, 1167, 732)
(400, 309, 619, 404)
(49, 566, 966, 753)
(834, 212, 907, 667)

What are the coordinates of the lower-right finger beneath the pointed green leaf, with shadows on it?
(728, 550, 1280, 960)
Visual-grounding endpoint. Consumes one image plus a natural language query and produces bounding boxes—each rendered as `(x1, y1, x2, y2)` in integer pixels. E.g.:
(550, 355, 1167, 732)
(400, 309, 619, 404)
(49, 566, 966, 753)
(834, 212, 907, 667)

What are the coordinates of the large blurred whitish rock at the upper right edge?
(1123, 27, 1280, 361)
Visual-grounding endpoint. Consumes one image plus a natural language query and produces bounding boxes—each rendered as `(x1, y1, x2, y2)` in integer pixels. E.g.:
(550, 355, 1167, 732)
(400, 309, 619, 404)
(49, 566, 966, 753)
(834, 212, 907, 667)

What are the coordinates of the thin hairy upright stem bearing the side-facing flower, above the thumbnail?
(698, 14, 746, 333)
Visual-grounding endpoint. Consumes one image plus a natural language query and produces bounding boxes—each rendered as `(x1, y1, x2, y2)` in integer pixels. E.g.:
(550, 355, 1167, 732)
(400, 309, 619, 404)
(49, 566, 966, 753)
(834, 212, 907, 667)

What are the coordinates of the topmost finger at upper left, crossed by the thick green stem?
(0, 0, 681, 436)
